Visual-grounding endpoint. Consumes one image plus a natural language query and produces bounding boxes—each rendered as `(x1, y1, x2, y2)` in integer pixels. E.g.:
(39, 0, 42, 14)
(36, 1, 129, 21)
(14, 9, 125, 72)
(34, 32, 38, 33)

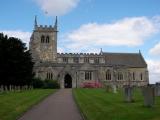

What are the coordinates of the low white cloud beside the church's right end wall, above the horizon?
(147, 60, 160, 83)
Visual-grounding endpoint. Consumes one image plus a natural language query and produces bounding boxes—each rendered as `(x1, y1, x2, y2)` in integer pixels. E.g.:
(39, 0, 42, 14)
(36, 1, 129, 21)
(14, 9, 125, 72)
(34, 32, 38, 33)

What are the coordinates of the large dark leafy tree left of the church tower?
(0, 33, 33, 86)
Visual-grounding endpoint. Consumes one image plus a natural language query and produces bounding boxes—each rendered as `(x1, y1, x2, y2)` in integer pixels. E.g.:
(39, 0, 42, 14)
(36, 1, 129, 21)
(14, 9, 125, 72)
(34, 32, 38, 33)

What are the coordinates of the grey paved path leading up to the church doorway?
(19, 89, 82, 120)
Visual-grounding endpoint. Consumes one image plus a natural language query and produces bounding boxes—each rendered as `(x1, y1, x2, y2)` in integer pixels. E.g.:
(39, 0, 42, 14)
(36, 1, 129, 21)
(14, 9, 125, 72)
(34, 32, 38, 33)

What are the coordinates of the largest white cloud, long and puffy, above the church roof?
(63, 17, 158, 51)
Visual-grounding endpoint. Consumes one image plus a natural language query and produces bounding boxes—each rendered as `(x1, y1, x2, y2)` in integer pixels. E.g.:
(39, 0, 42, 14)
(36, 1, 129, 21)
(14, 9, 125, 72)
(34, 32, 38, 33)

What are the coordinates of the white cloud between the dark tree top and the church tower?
(0, 30, 31, 47)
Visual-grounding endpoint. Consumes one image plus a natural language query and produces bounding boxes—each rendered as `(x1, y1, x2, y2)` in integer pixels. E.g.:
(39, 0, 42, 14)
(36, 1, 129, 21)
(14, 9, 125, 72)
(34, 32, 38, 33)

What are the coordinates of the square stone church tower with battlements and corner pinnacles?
(29, 16, 58, 62)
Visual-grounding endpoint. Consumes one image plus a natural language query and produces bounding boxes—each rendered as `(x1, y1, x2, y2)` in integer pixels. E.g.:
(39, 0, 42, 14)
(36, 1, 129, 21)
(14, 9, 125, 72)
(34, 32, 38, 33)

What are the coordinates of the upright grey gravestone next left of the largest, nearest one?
(124, 86, 134, 102)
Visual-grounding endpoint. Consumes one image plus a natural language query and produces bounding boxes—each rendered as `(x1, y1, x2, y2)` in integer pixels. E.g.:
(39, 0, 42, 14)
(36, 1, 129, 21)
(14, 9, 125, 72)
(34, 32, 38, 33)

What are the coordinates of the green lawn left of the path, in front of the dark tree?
(0, 89, 55, 120)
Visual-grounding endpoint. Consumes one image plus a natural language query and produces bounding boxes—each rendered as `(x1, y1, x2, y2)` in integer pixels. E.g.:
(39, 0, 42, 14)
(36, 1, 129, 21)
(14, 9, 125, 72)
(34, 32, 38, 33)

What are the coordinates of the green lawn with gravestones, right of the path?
(73, 89, 160, 120)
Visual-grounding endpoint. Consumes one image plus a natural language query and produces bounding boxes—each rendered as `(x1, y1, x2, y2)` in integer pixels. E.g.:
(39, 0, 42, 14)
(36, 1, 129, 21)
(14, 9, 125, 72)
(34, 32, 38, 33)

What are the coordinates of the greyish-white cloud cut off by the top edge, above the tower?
(35, 0, 79, 16)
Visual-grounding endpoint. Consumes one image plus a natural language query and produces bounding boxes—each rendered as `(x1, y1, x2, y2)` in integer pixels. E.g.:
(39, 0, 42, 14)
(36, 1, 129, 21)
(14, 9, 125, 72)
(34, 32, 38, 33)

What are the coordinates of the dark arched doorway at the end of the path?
(64, 74, 72, 88)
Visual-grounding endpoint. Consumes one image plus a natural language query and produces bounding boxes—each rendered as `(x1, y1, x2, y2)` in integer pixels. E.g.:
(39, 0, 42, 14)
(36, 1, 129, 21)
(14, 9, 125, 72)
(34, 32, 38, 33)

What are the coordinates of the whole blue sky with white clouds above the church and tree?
(0, 0, 160, 82)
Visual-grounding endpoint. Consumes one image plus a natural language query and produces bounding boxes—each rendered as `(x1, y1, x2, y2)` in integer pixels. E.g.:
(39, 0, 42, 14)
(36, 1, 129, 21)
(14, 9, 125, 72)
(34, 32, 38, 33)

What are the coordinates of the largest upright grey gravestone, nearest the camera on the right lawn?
(143, 85, 155, 107)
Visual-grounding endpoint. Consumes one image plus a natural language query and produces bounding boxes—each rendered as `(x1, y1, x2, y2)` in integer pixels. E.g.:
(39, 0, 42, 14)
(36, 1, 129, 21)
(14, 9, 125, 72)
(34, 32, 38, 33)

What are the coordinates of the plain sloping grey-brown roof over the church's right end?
(103, 52, 147, 68)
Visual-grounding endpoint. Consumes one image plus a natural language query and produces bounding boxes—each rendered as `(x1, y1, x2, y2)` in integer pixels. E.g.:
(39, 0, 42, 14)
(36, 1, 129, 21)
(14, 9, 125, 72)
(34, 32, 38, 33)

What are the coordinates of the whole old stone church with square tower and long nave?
(29, 17, 149, 88)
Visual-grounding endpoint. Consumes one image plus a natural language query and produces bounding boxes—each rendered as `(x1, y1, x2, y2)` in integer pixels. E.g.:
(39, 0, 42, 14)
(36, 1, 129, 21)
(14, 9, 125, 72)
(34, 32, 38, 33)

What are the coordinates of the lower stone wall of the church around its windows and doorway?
(35, 63, 148, 88)
